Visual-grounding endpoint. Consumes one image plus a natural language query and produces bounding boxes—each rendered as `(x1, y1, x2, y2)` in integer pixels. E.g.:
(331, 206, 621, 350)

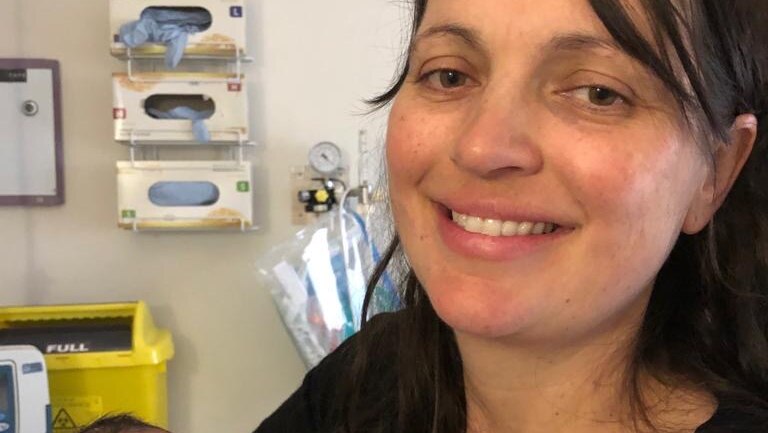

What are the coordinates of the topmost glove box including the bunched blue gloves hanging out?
(109, 0, 246, 59)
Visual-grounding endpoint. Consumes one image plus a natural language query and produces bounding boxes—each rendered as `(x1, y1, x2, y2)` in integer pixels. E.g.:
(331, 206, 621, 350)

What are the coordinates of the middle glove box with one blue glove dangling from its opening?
(112, 72, 248, 145)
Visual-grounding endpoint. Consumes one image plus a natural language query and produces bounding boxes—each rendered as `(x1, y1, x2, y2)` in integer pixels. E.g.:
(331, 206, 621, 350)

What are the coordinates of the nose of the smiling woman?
(451, 94, 543, 178)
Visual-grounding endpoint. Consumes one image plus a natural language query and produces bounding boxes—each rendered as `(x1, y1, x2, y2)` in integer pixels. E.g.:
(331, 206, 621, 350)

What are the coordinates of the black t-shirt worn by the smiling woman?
(254, 314, 768, 433)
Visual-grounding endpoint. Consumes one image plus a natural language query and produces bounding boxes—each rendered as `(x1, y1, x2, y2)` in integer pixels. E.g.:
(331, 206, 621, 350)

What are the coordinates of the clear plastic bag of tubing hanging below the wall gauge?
(256, 209, 400, 367)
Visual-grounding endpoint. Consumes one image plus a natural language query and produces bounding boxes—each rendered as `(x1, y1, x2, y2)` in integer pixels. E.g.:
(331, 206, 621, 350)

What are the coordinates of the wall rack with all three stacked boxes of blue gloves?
(110, 0, 256, 231)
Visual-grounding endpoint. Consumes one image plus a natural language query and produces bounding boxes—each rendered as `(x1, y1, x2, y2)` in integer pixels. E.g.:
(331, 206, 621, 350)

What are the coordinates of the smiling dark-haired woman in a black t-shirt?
(257, 0, 768, 433)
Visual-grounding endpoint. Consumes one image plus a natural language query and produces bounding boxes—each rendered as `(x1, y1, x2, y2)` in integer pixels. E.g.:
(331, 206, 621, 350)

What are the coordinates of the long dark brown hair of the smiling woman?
(341, 0, 768, 433)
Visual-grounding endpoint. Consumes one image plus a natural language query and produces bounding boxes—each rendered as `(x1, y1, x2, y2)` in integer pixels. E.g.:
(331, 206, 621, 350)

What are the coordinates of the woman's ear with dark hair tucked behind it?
(682, 114, 757, 234)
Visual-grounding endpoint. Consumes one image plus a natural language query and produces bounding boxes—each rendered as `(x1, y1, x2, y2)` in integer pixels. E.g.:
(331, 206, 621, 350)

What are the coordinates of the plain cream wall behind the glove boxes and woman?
(0, 0, 407, 433)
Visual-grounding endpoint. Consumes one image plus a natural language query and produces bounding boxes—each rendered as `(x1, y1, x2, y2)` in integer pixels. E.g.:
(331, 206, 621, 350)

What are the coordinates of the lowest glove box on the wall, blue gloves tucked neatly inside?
(117, 161, 253, 230)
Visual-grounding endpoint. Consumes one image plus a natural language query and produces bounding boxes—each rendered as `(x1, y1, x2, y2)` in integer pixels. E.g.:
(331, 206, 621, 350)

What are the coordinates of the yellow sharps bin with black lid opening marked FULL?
(0, 302, 173, 433)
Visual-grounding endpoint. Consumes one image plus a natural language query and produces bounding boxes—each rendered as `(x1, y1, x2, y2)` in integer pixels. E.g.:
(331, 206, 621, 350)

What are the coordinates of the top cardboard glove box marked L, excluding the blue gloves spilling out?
(109, 0, 246, 58)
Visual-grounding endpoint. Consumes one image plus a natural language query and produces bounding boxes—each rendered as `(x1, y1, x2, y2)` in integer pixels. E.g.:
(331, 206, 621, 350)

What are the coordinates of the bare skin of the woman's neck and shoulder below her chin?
(456, 306, 716, 433)
